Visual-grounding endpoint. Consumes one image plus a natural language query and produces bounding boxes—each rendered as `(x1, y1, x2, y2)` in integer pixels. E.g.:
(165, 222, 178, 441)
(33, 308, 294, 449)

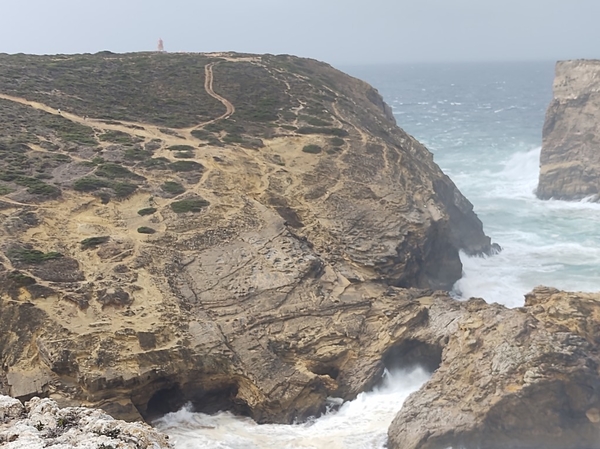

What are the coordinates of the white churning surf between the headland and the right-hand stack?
(454, 147, 600, 307)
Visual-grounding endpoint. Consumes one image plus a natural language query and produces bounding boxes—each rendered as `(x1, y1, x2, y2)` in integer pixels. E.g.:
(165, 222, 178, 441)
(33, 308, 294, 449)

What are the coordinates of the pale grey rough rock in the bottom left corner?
(0, 396, 172, 449)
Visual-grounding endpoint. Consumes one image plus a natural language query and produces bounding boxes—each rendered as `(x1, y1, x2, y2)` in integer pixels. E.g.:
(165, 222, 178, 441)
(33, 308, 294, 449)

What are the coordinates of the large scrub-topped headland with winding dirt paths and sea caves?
(0, 53, 491, 422)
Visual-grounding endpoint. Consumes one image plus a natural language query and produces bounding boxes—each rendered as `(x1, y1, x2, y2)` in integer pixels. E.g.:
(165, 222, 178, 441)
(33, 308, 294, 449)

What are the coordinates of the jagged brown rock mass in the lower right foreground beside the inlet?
(389, 287, 600, 449)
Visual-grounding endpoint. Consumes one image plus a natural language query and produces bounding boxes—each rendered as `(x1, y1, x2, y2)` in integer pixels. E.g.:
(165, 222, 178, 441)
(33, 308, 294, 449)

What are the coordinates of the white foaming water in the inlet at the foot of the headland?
(154, 368, 430, 449)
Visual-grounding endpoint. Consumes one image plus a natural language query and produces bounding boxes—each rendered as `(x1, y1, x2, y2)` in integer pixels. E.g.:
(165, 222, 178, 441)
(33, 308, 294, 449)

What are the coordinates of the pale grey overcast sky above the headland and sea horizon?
(0, 0, 600, 65)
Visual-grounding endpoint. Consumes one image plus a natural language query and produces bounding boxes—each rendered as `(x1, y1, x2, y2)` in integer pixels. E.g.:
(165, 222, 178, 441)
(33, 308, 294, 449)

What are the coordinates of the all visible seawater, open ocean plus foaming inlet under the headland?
(155, 62, 600, 449)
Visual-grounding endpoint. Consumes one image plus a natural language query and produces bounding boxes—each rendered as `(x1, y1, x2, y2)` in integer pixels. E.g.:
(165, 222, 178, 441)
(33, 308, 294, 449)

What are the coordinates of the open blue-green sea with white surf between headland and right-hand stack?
(345, 62, 600, 306)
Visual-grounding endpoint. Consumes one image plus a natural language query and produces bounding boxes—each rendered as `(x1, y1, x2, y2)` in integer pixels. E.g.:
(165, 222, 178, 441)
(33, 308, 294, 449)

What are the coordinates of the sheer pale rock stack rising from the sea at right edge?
(537, 60, 600, 201)
